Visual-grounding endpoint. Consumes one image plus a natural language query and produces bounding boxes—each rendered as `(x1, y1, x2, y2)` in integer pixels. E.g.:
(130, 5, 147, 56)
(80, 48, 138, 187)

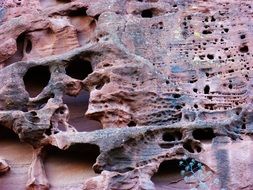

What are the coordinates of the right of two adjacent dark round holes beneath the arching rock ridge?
(66, 59, 92, 80)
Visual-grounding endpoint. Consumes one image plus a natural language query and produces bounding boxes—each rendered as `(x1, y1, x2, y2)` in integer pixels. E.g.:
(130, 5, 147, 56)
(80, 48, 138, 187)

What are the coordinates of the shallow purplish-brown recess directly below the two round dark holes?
(63, 91, 103, 131)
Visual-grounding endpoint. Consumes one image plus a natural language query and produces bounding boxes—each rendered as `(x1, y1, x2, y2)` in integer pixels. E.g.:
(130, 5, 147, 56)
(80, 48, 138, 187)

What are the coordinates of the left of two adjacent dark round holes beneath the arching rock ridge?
(23, 66, 51, 97)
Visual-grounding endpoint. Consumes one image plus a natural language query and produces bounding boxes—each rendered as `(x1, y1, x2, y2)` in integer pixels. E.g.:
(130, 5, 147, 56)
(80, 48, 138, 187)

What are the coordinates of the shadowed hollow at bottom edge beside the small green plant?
(151, 159, 189, 190)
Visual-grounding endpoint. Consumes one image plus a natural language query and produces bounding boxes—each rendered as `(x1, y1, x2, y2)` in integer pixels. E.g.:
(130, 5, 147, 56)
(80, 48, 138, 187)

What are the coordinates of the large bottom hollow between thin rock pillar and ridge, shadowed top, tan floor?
(44, 143, 100, 189)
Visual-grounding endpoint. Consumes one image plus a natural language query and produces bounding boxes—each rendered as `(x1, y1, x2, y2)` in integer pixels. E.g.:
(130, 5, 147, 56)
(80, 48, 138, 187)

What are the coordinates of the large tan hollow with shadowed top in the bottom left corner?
(0, 125, 33, 190)
